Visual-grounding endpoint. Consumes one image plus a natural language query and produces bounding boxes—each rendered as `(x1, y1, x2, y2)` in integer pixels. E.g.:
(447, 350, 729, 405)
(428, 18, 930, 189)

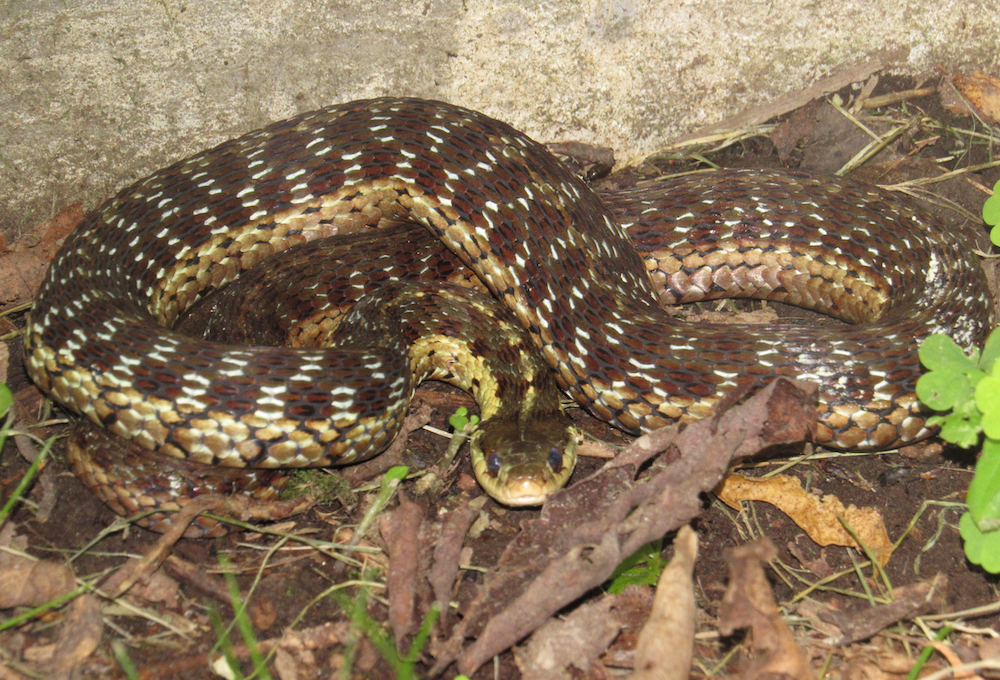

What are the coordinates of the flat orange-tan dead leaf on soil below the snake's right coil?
(715, 473, 892, 565)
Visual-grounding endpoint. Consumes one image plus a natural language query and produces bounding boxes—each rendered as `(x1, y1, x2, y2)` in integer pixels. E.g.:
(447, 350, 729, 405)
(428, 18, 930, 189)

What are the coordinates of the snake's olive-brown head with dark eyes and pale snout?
(471, 412, 580, 506)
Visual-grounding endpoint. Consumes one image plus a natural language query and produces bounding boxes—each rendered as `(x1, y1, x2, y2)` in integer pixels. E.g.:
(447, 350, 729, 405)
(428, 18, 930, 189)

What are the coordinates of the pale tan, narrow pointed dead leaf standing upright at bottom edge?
(629, 526, 698, 680)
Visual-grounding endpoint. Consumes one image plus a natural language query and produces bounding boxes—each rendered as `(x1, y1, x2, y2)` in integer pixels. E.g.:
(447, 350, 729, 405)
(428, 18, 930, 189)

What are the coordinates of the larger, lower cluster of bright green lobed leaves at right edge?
(917, 330, 1000, 574)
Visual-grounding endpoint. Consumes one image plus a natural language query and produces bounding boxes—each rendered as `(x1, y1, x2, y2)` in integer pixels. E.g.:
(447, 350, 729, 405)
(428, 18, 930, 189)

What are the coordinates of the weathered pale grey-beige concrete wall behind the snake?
(0, 0, 1000, 238)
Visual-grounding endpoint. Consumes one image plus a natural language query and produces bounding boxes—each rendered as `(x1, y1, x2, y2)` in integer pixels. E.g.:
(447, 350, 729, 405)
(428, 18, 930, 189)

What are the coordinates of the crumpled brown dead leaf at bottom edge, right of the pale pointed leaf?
(719, 537, 816, 680)
